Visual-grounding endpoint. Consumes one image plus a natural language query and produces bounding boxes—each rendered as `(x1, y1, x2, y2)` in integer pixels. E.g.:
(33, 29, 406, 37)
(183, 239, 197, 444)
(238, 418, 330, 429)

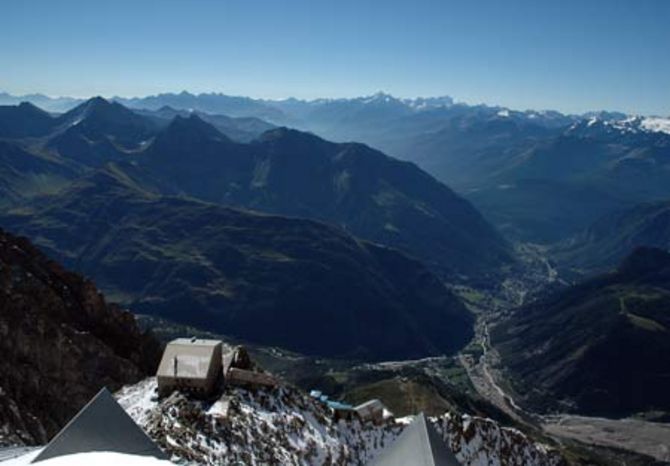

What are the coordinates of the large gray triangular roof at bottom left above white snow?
(32, 388, 166, 463)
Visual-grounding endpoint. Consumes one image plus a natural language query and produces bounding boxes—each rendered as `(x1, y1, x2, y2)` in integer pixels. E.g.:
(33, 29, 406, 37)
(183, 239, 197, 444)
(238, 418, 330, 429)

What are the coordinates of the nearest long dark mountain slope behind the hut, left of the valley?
(0, 172, 480, 359)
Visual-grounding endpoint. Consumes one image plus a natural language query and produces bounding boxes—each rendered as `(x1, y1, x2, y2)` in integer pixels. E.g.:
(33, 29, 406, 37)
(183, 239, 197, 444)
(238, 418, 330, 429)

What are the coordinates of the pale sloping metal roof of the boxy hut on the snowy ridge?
(156, 338, 221, 379)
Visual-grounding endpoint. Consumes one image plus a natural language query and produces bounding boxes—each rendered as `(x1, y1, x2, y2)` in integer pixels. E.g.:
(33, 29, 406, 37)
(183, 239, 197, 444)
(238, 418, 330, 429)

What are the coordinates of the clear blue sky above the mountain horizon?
(0, 0, 670, 115)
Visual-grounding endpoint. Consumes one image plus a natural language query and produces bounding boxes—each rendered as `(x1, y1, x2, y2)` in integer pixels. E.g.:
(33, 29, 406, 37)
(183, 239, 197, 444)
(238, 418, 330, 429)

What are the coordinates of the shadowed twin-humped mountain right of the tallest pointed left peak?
(140, 116, 512, 277)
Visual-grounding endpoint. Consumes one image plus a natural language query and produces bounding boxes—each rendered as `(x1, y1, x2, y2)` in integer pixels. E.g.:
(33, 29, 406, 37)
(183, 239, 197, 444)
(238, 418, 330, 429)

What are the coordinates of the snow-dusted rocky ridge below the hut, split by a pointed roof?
(117, 379, 561, 466)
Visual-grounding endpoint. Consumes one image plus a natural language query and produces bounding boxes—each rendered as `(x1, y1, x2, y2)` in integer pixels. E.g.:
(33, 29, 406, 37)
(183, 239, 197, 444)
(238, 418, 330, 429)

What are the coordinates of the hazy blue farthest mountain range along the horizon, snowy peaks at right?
(0, 92, 670, 243)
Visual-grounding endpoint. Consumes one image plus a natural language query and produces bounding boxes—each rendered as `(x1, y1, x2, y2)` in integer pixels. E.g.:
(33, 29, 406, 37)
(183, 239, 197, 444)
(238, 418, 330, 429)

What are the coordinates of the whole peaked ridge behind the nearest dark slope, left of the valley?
(0, 98, 513, 279)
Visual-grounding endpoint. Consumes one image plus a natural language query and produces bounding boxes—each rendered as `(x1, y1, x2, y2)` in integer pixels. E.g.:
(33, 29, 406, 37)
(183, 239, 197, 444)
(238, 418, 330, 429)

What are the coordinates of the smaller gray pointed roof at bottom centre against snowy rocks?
(368, 413, 460, 466)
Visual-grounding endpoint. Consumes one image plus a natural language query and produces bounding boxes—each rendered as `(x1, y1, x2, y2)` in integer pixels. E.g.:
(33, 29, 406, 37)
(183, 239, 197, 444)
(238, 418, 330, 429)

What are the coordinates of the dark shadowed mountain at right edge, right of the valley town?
(491, 248, 670, 416)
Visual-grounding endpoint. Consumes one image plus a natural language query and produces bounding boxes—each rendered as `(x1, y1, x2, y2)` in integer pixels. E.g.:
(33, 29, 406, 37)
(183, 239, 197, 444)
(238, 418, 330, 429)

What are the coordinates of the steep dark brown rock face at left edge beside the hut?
(0, 230, 160, 444)
